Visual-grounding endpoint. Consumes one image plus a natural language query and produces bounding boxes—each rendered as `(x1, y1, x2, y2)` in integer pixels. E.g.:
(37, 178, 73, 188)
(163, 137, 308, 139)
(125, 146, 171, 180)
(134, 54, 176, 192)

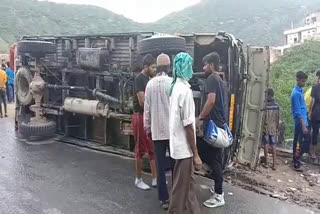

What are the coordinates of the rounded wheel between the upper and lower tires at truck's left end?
(15, 67, 33, 105)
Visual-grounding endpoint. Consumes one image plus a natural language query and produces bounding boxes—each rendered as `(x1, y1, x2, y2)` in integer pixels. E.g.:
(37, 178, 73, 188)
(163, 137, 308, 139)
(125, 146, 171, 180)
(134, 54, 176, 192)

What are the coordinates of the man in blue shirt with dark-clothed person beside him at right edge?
(291, 71, 320, 169)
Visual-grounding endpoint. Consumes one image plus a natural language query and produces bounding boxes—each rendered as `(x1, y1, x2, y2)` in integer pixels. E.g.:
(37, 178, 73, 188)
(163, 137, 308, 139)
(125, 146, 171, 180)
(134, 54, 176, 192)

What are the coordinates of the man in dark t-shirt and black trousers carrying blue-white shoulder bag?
(197, 52, 226, 208)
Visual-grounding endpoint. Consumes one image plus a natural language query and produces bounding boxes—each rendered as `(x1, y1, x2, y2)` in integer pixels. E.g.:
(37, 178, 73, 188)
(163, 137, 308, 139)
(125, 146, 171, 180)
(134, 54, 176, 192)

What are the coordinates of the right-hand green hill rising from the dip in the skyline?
(150, 0, 320, 45)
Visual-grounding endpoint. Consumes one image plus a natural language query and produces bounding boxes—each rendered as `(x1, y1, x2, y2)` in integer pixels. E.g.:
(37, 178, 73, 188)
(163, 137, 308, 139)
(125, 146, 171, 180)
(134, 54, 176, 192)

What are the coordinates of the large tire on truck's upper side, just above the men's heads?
(138, 36, 186, 55)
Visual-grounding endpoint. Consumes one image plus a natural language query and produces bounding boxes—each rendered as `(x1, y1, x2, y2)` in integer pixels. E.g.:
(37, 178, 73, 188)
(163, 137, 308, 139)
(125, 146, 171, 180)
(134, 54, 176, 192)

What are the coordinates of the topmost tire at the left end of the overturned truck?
(17, 40, 56, 57)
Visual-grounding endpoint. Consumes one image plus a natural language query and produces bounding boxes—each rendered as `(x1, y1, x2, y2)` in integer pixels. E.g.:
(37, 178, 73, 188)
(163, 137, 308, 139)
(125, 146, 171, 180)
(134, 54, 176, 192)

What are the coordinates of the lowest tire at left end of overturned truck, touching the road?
(18, 121, 56, 139)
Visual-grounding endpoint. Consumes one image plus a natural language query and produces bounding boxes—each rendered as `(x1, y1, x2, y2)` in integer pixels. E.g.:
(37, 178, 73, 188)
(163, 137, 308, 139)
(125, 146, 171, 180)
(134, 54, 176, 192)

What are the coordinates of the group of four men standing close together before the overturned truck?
(132, 52, 226, 214)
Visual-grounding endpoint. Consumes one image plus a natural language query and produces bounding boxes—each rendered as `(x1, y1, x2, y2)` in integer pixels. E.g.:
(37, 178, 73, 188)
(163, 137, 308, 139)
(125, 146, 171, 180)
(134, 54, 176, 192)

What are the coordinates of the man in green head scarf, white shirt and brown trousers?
(168, 53, 202, 214)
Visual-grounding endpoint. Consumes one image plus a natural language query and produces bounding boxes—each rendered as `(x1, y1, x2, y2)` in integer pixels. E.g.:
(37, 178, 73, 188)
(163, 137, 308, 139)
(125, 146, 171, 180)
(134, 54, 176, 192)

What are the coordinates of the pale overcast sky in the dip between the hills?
(42, 0, 200, 22)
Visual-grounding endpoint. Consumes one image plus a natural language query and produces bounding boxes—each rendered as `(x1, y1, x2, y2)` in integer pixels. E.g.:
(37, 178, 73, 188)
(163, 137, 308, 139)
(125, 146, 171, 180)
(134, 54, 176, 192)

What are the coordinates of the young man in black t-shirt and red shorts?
(132, 54, 157, 190)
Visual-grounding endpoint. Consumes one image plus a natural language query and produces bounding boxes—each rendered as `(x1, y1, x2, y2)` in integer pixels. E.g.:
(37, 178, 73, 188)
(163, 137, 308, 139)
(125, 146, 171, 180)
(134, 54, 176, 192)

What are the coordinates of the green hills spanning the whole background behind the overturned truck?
(0, 0, 320, 52)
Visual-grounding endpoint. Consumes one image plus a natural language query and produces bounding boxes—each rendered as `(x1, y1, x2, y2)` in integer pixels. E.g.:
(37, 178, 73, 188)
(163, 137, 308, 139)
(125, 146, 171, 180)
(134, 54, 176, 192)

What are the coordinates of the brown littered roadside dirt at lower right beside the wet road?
(225, 152, 320, 210)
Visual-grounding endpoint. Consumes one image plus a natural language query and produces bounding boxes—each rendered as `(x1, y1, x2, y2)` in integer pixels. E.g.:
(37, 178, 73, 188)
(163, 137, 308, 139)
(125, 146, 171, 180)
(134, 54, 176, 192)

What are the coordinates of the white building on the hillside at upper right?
(284, 12, 320, 46)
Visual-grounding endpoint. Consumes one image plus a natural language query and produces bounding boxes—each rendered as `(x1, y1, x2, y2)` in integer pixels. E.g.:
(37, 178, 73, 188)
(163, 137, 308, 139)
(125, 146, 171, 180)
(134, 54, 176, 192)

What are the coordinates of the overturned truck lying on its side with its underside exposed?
(14, 32, 270, 167)
